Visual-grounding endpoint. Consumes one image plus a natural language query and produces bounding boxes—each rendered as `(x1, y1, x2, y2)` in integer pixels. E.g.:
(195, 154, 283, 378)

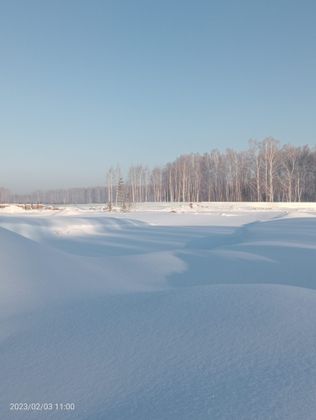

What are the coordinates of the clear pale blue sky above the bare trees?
(0, 0, 316, 192)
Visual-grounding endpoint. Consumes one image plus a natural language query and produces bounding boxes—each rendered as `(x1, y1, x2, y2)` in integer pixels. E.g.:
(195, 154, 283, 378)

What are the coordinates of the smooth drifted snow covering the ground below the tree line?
(0, 203, 316, 420)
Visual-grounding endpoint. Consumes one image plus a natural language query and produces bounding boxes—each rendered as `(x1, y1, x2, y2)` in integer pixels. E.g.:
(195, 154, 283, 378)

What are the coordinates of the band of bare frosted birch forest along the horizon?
(0, 137, 316, 205)
